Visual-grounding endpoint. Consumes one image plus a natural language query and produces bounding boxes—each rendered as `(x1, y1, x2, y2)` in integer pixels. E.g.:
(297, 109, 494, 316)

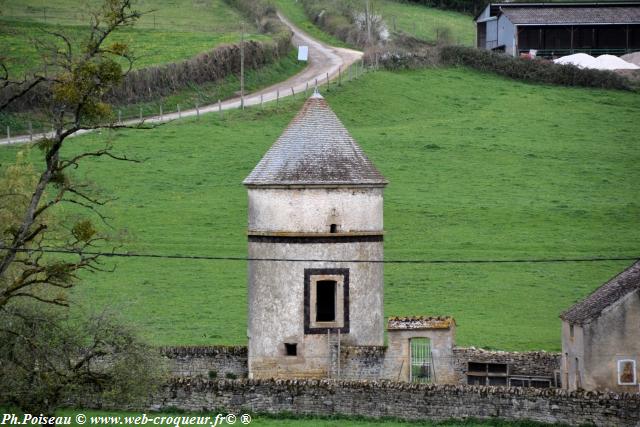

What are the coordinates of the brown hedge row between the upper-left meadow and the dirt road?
(0, 0, 292, 111)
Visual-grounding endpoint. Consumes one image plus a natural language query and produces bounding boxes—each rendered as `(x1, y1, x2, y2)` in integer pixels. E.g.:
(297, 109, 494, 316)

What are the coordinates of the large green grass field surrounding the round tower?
(0, 69, 640, 350)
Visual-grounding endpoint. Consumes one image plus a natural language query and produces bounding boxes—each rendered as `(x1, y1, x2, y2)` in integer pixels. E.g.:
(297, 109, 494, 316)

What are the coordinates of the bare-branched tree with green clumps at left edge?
(0, 0, 148, 310)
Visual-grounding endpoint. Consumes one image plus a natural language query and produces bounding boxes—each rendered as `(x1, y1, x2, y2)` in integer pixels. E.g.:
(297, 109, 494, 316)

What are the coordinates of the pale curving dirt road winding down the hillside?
(0, 13, 362, 145)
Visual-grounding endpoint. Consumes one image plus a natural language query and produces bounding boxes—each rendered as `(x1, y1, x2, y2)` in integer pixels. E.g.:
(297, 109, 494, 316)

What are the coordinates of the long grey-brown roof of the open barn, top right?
(501, 5, 640, 25)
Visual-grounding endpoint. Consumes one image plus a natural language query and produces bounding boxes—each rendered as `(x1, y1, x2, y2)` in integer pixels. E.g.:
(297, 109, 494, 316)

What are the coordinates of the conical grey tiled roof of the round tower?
(243, 93, 387, 186)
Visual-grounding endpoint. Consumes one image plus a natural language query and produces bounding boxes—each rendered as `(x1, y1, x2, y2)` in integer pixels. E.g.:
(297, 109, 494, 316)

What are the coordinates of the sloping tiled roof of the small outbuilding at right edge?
(560, 261, 640, 324)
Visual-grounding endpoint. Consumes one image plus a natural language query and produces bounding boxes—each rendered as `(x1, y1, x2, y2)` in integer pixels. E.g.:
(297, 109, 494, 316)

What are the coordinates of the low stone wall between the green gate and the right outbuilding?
(453, 347, 561, 384)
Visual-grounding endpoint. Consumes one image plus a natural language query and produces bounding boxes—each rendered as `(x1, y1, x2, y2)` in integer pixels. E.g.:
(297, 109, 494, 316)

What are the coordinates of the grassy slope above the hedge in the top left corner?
(0, 0, 267, 73)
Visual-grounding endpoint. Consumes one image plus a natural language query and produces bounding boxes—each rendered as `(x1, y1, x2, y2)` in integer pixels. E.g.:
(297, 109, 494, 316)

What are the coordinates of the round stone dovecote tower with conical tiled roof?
(243, 93, 387, 378)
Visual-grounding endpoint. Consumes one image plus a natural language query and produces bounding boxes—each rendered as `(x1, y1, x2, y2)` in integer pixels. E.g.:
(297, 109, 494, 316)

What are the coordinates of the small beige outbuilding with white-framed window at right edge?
(560, 261, 640, 392)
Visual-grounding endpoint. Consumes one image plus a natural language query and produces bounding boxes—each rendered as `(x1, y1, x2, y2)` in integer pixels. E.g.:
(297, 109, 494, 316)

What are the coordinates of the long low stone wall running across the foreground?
(155, 378, 640, 426)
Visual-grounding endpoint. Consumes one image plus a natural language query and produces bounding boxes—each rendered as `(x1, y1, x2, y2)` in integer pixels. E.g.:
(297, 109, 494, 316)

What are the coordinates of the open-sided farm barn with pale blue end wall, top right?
(475, 2, 640, 57)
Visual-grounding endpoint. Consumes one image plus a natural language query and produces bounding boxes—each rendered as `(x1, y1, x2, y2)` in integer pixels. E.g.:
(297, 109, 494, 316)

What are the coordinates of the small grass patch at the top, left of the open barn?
(380, 0, 475, 46)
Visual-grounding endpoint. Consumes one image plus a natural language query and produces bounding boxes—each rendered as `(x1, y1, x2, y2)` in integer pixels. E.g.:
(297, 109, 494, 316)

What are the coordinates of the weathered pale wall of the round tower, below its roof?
(248, 188, 384, 378)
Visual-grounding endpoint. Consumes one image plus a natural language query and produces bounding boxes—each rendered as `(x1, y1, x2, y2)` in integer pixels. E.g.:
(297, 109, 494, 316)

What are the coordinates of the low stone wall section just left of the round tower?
(160, 346, 248, 378)
